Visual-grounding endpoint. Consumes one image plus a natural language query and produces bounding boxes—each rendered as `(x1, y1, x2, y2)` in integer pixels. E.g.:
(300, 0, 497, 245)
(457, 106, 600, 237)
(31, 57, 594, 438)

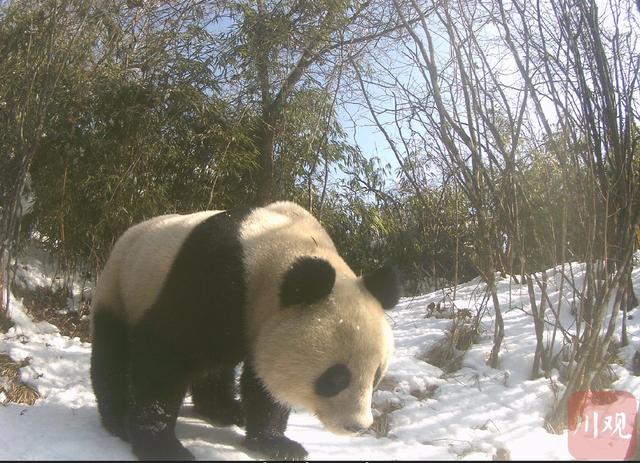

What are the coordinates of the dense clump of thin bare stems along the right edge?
(499, 0, 640, 430)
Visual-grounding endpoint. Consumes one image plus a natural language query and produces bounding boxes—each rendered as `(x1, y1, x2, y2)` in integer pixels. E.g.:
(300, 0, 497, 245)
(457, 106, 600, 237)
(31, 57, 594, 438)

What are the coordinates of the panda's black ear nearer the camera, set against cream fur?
(280, 256, 336, 307)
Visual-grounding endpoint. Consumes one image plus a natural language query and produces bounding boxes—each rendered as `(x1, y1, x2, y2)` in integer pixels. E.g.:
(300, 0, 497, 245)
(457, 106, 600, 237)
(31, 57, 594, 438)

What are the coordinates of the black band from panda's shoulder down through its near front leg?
(126, 212, 254, 459)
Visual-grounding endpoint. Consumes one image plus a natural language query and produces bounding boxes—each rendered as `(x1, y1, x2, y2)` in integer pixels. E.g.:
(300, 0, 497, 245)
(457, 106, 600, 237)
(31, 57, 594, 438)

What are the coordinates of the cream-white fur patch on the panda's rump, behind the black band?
(93, 211, 222, 324)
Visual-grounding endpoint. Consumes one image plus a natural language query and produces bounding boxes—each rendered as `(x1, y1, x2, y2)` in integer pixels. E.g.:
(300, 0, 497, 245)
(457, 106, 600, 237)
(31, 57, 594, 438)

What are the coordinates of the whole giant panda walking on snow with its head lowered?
(91, 202, 399, 459)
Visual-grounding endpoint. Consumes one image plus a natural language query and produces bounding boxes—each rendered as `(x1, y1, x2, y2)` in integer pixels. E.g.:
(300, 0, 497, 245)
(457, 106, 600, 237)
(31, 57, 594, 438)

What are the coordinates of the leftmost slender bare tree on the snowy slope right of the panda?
(369, 0, 528, 367)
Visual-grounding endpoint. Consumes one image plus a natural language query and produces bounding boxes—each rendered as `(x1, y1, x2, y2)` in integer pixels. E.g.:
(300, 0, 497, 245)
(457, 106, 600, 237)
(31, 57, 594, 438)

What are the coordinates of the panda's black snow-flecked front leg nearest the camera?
(125, 338, 194, 460)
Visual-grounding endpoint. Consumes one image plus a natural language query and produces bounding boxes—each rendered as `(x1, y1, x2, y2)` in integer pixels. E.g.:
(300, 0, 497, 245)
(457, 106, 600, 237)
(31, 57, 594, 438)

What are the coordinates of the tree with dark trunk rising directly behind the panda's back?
(215, 0, 418, 204)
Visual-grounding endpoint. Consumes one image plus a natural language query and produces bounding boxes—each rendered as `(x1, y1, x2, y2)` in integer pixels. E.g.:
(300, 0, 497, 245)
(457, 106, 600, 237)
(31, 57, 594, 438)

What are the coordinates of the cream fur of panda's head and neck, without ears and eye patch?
(241, 202, 393, 432)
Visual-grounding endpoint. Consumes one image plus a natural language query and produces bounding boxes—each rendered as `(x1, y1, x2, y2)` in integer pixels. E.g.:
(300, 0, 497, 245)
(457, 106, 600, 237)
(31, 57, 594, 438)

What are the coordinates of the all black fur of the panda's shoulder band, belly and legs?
(91, 210, 306, 459)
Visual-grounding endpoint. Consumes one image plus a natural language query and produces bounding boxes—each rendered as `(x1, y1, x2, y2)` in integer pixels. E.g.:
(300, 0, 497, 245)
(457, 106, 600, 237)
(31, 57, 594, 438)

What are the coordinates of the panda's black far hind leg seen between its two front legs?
(191, 364, 244, 426)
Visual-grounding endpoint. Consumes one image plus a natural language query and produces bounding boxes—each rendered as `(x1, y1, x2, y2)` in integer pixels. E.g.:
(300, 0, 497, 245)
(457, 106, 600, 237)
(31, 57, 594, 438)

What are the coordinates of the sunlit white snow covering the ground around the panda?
(0, 255, 640, 460)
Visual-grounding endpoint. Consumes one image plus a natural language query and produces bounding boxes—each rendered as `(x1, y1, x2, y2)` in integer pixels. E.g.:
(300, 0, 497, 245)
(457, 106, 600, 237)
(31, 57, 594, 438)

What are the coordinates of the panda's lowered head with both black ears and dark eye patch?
(254, 256, 399, 433)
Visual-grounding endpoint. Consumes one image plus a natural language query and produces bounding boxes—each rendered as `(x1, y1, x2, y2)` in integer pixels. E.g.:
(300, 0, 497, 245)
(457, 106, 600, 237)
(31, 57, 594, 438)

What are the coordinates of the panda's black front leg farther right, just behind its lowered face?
(240, 359, 308, 460)
